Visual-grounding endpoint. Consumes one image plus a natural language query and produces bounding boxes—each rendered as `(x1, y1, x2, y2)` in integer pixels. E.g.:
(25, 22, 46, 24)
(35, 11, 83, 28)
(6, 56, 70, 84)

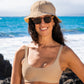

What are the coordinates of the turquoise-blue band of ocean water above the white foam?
(0, 17, 84, 38)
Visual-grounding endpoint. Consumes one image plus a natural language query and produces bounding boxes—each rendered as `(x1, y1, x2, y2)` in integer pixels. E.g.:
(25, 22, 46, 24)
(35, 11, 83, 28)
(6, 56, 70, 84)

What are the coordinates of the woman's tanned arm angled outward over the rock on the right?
(66, 47, 84, 83)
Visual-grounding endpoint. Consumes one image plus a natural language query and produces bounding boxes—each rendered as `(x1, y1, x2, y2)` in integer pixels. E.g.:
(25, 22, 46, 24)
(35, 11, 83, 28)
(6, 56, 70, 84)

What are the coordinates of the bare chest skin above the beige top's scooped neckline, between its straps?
(28, 49, 58, 67)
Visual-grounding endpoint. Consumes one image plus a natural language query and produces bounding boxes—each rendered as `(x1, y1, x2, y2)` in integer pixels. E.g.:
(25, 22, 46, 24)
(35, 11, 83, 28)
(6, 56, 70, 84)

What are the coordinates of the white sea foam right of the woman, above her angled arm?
(65, 34, 84, 63)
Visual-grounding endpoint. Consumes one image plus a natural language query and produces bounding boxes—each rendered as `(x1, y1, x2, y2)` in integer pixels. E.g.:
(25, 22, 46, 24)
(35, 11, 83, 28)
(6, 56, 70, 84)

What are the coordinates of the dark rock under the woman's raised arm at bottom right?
(59, 68, 83, 84)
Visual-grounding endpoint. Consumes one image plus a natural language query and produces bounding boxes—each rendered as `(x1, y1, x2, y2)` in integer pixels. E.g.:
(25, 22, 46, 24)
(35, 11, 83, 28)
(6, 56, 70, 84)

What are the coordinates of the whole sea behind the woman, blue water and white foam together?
(0, 16, 84, 64)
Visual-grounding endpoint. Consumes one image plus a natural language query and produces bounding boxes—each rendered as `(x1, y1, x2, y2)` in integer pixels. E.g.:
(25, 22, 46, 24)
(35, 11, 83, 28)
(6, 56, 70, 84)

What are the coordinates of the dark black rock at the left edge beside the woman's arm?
(0, 54, 12, 84)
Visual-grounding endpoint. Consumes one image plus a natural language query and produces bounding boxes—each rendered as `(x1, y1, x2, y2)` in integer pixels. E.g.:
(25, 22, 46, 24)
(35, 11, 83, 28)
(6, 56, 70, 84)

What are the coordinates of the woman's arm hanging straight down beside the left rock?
(11, 46, 25, 84)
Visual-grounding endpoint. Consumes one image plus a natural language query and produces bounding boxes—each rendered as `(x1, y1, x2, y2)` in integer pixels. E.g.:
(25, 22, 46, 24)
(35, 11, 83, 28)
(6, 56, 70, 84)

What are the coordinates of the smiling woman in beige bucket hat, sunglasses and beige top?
(11, 0, 84, 84)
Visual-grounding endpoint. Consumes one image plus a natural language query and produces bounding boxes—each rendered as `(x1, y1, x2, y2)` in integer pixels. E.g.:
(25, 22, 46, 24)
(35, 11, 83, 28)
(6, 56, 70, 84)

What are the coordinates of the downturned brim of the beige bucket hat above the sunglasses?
(24, 12, 62, 23)
